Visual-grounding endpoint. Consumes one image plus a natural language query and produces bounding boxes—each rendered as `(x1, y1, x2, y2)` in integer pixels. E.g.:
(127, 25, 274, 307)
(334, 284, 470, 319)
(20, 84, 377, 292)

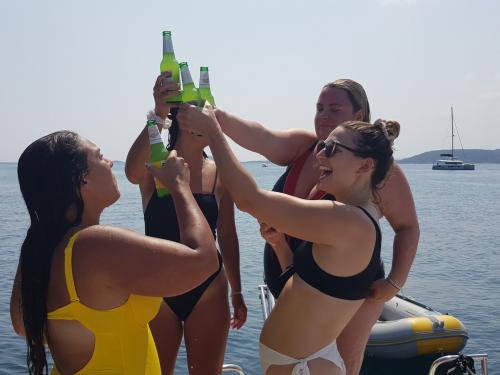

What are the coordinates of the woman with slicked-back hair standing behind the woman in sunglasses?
(205, 79, 420, 375)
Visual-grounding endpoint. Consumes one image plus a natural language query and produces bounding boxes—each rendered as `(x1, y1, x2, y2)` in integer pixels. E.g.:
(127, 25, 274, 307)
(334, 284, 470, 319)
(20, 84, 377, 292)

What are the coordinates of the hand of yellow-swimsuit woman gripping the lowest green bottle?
(146, 150, 190, 191)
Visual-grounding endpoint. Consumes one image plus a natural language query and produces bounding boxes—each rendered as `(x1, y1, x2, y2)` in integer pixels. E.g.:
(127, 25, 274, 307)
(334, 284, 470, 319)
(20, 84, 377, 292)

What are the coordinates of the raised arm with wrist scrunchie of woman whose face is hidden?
(125, 71, 179, 184)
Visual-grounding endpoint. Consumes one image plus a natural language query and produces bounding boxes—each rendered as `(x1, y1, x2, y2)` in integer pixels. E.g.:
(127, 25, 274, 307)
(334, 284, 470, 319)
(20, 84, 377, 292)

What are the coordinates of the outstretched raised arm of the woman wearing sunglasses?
(177, 105, 374, 250)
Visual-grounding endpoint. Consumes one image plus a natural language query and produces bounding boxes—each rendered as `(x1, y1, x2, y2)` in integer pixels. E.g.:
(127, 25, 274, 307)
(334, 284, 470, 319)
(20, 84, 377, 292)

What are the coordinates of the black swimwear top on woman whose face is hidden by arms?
(144, 178, 219, 242)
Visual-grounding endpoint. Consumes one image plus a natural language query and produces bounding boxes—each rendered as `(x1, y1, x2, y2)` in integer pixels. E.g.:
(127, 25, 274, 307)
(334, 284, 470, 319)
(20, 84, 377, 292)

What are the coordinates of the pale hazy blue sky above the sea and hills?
(0, 0, 500, 162)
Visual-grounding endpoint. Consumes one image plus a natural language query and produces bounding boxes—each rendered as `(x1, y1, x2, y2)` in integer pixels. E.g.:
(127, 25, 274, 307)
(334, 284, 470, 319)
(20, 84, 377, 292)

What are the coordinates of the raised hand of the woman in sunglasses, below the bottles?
(177, 102, 220, 137)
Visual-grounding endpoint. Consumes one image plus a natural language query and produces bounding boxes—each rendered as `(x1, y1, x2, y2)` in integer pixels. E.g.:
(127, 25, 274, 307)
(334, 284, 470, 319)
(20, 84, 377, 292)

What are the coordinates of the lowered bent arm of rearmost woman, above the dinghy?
(373, 164, 420, 301)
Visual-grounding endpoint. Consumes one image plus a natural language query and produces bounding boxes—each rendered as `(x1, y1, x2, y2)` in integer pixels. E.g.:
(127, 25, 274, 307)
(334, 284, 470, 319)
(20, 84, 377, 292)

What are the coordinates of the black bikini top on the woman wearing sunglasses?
(293, 207, 382, 300)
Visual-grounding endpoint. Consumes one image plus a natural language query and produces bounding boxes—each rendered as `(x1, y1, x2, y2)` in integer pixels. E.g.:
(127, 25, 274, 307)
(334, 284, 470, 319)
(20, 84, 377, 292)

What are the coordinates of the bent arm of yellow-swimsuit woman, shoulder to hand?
(84, 151, 219, 296)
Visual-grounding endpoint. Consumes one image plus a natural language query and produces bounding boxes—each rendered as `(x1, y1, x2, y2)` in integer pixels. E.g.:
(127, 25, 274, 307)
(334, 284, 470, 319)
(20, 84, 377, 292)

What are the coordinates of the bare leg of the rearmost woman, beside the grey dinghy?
(337, 301, 384, 375)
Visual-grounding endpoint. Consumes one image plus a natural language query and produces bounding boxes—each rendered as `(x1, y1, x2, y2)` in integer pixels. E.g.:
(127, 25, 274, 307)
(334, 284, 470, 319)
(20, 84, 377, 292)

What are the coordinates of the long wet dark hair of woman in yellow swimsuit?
(17, 131, 88, 374)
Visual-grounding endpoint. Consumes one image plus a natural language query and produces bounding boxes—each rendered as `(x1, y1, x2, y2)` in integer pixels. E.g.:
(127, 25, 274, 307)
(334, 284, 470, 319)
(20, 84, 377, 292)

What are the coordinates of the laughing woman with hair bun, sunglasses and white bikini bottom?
(177, 101, 399, 375)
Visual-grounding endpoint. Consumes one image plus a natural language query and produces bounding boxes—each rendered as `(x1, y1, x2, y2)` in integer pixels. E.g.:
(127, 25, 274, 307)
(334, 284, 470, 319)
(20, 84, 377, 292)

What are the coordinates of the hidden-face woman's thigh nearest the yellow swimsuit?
(149, 302, 186, 375)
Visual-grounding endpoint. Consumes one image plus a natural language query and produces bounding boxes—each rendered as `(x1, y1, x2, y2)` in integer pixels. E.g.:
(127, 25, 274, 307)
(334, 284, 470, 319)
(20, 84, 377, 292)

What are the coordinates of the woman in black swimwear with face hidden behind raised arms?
(125, 72, 247, 375)
